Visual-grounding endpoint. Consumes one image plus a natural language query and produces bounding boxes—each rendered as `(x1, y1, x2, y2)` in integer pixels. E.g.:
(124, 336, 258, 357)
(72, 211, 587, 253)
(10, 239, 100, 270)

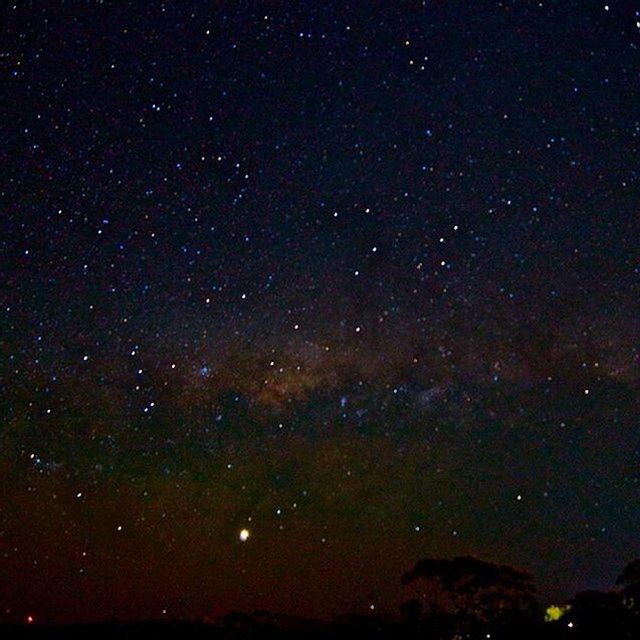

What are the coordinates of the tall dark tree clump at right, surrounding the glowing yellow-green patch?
(400, 556, 640, 640)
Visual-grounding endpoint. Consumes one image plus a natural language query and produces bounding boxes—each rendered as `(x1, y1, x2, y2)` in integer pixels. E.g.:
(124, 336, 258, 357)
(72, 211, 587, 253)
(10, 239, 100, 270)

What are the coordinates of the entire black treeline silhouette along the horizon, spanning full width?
(0, 556, 640, 640)
